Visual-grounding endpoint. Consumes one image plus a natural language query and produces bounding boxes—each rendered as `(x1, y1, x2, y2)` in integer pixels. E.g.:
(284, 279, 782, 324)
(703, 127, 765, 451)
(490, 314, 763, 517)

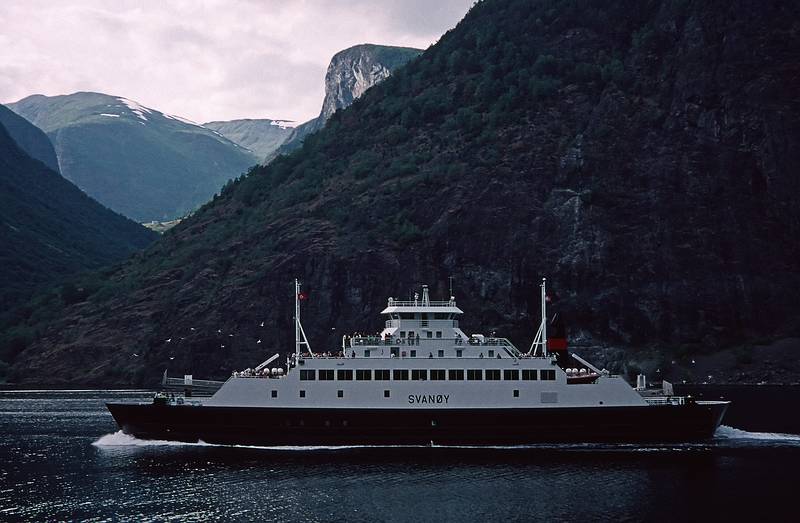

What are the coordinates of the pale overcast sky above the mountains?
(0, 0, 474, 122)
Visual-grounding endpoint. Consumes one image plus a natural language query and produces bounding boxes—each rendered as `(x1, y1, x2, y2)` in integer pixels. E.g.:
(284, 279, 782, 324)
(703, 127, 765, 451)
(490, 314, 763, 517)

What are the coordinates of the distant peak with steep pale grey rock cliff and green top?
(265, 44, 422, 162)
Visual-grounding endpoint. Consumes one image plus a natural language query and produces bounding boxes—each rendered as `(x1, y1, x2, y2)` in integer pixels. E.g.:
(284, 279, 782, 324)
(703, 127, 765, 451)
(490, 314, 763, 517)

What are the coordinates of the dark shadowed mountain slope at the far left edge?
(0, 106, 157, 312)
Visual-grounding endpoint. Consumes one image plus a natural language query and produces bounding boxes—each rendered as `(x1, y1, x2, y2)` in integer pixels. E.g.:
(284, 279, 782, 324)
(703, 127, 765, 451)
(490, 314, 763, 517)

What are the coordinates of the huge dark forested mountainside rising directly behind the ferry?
(6, 0, 800, 383)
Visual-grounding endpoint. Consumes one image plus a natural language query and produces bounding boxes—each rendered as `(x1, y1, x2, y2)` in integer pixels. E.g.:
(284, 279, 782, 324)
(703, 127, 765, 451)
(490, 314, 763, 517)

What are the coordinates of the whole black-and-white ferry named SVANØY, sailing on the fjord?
(107, 280, 728, 446)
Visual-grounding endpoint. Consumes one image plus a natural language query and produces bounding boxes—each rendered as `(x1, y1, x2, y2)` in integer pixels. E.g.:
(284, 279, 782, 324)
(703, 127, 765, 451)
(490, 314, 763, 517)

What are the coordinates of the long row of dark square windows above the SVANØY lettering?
(300, 369, 556, 381)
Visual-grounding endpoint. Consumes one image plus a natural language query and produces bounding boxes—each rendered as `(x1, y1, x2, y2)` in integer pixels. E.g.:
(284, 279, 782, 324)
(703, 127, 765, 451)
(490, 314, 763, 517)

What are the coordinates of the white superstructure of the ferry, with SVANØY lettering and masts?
(202, 281, 647, 409)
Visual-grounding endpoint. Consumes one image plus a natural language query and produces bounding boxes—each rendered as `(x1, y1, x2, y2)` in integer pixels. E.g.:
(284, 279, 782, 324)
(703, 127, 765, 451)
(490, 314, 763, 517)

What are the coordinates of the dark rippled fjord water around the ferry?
(0, 391, 800, 521)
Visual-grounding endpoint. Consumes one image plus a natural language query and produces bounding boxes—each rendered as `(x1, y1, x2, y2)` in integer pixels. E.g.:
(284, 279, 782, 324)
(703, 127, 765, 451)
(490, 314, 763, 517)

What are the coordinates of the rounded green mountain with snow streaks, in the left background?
(9, 92, 256, 222)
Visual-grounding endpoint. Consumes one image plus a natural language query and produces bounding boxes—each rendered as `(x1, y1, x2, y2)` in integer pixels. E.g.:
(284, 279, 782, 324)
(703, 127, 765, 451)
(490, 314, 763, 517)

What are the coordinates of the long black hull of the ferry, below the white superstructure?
(108, 402, 728, 446)
